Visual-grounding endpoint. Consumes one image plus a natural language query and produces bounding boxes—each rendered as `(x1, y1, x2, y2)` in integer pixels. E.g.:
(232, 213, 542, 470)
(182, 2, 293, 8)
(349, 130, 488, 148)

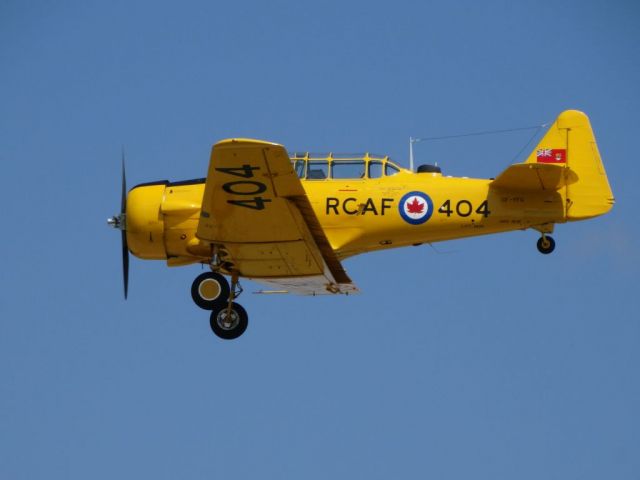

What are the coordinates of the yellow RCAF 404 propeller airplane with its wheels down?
(108, 110, 614, 339)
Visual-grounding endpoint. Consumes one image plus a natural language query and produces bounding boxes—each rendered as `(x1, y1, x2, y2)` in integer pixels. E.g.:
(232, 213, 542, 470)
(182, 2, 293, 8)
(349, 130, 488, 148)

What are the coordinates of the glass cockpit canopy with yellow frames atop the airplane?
(289, 152, 400, 180)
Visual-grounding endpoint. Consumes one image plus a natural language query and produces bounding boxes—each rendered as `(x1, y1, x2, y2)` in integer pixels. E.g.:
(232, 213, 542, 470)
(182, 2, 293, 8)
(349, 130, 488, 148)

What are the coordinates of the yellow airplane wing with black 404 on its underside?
(197, 139, 357, 295)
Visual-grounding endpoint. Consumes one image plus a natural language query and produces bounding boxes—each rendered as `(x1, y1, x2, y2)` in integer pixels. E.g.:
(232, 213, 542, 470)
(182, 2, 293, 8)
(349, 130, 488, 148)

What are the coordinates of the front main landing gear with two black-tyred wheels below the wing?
(191, 272, 249, 340)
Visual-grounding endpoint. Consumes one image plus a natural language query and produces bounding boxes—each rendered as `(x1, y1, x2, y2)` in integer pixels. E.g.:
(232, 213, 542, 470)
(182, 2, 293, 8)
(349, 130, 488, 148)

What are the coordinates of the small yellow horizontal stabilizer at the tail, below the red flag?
(490, 163, 578, 191)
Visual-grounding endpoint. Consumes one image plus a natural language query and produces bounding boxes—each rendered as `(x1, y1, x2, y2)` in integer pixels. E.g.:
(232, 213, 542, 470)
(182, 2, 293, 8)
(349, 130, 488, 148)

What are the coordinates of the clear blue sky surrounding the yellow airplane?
(0, 0, 640, 479)
